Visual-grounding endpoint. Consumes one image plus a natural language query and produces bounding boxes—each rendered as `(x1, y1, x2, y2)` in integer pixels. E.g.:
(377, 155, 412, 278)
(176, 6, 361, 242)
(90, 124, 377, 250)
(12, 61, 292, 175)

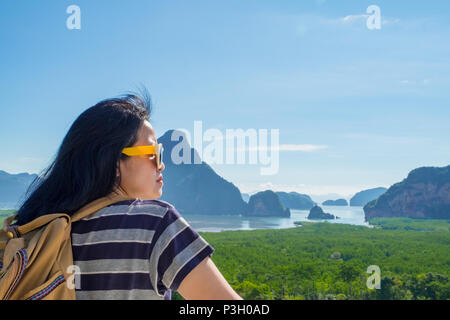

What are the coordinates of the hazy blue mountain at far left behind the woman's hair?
(0, 170, 38, 209)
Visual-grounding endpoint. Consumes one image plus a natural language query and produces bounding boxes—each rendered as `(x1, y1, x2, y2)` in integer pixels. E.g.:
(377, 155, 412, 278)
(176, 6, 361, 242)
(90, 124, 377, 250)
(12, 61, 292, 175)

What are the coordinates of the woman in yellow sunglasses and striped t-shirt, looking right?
(17, 94, 242, 300)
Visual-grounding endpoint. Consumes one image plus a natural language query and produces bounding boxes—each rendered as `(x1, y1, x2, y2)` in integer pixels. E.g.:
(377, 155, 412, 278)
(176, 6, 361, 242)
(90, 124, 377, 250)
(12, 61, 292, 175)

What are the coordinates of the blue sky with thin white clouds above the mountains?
(0, 0, 450, 200)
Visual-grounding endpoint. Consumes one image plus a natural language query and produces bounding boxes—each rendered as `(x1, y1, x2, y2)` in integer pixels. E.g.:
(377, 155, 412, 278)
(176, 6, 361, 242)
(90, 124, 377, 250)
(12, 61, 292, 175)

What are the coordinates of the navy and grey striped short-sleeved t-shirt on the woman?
(71, 199, 214, 300)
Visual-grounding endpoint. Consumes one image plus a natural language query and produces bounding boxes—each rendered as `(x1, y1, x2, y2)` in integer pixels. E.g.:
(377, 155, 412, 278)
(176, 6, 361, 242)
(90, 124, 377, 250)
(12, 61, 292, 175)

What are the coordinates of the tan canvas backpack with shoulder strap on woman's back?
(0, 195, 136, 300)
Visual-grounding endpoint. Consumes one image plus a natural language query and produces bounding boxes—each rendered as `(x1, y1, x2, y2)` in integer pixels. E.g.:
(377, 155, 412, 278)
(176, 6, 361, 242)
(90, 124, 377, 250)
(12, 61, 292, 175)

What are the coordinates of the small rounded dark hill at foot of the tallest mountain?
(244, 190, 291, 218)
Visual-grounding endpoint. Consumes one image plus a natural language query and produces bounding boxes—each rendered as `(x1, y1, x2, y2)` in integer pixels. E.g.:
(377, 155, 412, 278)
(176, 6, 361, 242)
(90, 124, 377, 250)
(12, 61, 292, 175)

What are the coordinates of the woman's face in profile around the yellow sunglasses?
(119, 120, 164, 200)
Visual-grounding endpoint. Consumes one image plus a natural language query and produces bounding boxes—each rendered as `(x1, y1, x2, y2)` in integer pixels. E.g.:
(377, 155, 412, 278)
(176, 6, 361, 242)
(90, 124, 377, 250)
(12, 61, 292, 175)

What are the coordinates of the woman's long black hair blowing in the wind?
(16, 90, 152, 225)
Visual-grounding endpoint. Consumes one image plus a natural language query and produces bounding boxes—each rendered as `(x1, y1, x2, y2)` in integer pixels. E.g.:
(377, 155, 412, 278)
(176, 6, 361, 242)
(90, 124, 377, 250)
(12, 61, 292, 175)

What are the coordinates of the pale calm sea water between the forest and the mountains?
(182, 206, 371, 232)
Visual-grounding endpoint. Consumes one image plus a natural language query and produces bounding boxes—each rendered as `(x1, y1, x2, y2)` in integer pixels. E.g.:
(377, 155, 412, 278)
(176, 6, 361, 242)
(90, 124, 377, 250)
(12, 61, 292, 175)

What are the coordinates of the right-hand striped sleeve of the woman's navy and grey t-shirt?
(150, 206, 214, 295)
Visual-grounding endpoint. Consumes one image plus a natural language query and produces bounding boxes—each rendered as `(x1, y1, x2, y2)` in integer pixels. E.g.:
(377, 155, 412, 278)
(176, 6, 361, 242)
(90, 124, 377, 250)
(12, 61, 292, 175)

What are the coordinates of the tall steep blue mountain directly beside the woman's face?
(158, 130, 247, 215)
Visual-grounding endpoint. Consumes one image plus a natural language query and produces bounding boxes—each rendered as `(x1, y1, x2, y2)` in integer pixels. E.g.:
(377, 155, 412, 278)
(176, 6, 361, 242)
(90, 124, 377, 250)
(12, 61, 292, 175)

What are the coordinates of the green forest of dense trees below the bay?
(0, 210, 450, 300)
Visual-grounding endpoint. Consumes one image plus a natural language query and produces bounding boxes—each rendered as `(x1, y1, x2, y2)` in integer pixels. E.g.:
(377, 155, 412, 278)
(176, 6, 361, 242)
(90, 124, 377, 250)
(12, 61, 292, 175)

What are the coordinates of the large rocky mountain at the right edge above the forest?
(364, 166, 450, 221)
